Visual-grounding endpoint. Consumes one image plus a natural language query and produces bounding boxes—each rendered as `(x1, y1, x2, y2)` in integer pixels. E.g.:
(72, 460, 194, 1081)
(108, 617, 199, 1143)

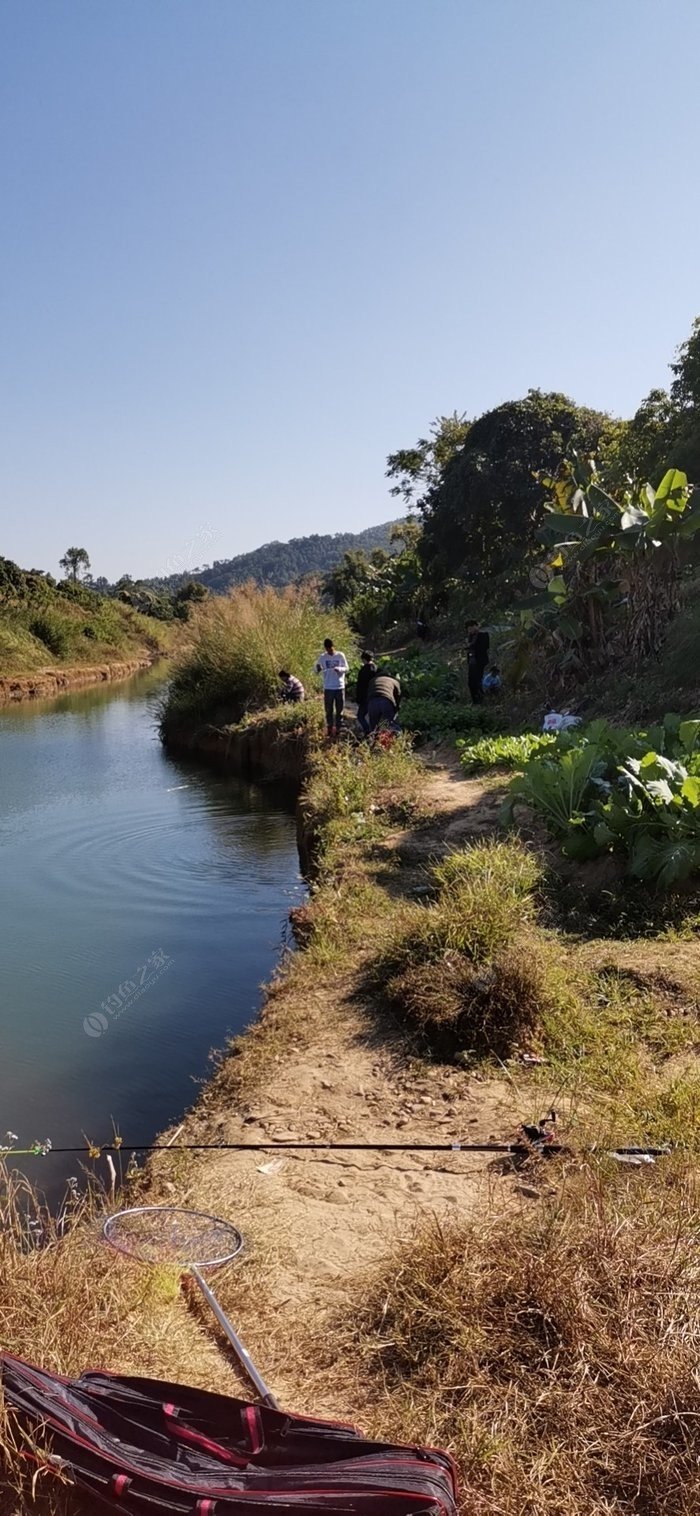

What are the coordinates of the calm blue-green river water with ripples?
(0, 670, 302, 1195)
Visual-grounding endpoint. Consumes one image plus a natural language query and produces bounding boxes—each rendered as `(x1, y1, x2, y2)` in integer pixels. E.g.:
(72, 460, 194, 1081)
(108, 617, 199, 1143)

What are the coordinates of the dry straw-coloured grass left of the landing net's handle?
(0, 1166, 251, 1516)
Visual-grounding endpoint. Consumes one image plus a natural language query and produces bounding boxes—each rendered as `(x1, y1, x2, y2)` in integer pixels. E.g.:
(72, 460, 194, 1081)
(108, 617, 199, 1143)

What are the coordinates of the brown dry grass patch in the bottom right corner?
(342, 1166, 700, 1516)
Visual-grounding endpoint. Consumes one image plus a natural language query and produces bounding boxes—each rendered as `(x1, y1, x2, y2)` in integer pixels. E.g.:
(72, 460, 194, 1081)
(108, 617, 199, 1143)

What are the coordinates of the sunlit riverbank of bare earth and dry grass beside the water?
(0, 711, 700, 1516)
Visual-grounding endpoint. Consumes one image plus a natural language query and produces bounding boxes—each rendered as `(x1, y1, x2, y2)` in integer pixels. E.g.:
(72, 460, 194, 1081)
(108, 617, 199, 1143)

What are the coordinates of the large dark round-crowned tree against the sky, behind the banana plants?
(418, 390, 612, 602)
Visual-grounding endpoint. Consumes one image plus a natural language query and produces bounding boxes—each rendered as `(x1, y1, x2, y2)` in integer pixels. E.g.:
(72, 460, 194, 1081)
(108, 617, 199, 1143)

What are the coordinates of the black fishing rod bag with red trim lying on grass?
(0, 1352, 456, 1516)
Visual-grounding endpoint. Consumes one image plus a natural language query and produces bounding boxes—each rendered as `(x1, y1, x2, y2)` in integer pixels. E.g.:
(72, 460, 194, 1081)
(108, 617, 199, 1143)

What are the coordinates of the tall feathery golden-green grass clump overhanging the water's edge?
(162, 584, 352, 729)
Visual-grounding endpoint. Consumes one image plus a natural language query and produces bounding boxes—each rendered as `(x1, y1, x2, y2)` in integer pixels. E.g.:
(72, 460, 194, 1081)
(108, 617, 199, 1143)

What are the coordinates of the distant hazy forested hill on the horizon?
(145, 522, 398, 594)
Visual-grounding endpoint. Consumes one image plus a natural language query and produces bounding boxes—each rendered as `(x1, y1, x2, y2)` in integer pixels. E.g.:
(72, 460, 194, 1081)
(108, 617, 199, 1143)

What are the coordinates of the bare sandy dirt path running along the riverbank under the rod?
(144, 769, 526, 1416)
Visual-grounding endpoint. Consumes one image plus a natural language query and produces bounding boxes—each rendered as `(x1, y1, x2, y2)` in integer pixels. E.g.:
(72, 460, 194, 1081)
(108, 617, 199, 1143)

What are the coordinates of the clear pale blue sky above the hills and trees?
(0, 0, 700, 578)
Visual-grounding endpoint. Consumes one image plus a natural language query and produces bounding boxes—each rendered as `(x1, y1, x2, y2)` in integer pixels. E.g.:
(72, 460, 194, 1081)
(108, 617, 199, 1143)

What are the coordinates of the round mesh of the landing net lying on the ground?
(103, 1205, 242, 1269)
